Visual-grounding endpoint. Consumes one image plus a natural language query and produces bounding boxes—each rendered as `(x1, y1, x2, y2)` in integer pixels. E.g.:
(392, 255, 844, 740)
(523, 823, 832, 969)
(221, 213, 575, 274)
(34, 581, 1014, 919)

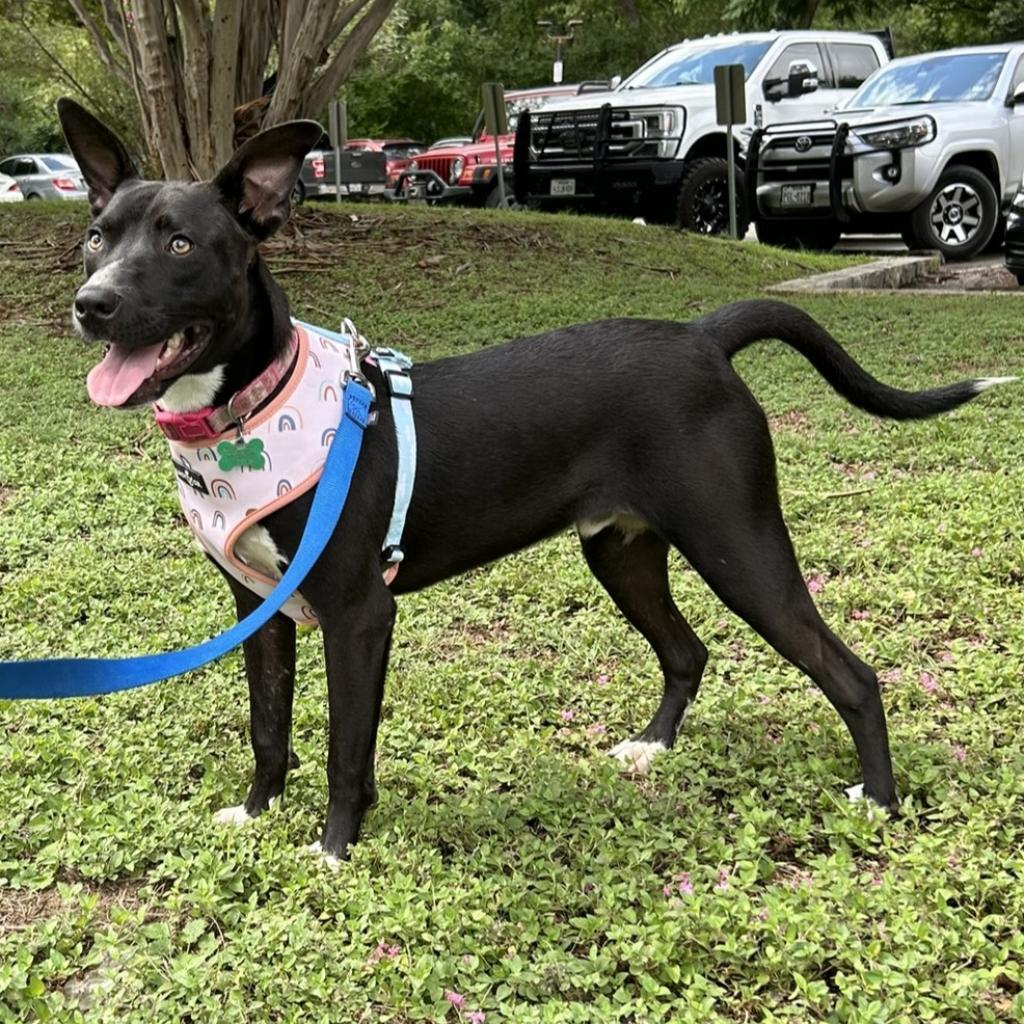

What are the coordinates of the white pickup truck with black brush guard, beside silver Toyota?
(515, 31, 890, 234)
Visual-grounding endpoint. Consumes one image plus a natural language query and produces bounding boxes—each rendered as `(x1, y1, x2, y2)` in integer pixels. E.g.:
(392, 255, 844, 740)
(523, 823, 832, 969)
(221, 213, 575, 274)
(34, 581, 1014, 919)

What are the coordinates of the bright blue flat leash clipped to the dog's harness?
(0, 377, 373, 700)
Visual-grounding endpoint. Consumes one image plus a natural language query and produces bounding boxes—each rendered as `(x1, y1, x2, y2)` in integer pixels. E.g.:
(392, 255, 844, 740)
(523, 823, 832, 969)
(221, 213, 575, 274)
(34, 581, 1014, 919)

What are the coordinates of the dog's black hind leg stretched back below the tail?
(649, 411, 896, 807)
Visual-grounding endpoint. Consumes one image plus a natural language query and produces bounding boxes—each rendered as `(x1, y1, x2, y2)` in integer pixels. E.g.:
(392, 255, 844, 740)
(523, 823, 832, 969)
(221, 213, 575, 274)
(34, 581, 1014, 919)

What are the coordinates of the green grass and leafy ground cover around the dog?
(0, 205, 1024, 1024)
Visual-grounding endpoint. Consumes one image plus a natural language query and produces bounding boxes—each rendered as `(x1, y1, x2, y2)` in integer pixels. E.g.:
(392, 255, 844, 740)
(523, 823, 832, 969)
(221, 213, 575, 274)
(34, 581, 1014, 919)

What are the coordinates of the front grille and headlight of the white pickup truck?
(530, 109, 683, 163)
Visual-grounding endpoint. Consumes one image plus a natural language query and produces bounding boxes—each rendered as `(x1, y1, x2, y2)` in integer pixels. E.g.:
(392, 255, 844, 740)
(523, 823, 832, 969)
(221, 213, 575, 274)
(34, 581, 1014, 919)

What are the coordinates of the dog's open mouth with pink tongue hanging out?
(86, 324, 211, 407)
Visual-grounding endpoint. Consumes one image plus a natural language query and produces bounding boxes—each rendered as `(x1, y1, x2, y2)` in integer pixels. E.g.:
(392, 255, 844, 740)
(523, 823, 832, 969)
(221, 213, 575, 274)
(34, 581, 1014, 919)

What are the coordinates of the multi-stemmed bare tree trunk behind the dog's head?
(71, 0, 396, 179)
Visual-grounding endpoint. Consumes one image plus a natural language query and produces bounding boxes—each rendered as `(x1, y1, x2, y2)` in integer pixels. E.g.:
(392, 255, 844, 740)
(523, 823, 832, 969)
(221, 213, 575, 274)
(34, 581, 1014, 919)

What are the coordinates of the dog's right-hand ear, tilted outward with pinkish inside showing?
(213, 121, 324, 241)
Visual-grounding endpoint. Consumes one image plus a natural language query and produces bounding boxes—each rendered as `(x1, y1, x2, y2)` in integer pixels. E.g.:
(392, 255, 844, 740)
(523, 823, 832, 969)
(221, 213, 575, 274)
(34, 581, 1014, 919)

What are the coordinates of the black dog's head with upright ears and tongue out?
(57, 99, 323, 408)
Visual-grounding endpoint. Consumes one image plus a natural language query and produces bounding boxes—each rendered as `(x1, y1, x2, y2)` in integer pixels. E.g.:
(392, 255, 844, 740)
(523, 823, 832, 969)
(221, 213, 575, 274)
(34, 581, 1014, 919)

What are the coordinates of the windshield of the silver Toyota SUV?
(846, 53, 1007, 106)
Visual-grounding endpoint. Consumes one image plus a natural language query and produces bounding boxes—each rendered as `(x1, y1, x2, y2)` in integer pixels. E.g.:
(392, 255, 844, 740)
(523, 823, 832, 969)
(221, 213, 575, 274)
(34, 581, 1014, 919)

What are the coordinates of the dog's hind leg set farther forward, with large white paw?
(581, 525, 708, 773)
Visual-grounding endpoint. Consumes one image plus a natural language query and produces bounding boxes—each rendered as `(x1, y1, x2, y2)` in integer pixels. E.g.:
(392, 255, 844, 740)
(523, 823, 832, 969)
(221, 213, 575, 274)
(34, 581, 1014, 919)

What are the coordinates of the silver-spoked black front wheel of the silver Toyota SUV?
(910, 164, 999, 259)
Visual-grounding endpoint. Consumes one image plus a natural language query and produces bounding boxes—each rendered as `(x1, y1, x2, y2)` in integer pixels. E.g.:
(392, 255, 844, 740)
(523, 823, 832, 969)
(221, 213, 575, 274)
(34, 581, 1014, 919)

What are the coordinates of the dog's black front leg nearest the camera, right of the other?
(316, 575, 395, 857)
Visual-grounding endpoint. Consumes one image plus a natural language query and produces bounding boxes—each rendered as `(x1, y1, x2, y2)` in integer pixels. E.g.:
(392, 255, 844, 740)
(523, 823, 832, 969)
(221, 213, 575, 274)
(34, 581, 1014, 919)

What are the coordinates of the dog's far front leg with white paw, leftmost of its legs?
(214, 578, 298, 824)
